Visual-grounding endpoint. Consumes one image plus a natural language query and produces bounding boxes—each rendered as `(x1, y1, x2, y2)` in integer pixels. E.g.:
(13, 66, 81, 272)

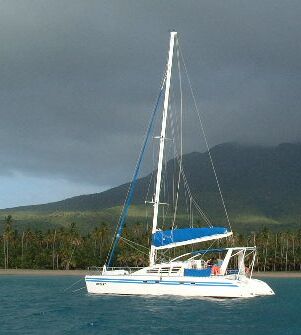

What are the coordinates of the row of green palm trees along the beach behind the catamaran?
(0, 215, 301, 271)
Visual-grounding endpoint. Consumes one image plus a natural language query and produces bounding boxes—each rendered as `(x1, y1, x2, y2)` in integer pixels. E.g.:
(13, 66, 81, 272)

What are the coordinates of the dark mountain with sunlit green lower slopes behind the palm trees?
(0, 143, 301, 231)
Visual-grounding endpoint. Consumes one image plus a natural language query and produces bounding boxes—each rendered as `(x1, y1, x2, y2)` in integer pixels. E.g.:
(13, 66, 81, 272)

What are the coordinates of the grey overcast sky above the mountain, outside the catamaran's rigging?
(0, 0, 301, 208)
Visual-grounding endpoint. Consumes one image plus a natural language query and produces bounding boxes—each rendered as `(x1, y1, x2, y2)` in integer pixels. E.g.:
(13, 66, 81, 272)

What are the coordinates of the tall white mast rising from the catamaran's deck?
(149, 31, 177, 266)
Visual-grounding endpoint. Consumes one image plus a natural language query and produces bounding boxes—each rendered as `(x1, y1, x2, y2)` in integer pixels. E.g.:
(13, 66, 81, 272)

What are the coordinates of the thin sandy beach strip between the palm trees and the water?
(0, 269, 301, 278)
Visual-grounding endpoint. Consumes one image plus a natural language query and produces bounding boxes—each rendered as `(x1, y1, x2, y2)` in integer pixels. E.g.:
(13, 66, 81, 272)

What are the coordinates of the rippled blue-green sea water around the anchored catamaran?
(0, 276, 301, 335)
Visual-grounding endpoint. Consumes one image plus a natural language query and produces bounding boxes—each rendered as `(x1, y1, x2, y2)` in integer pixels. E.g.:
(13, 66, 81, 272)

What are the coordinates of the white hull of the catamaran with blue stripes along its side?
(85, 275, 274, 298)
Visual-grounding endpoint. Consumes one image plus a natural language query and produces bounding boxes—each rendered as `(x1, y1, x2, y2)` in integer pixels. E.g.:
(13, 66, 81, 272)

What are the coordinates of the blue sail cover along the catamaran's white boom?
(152, 227, 232, 249)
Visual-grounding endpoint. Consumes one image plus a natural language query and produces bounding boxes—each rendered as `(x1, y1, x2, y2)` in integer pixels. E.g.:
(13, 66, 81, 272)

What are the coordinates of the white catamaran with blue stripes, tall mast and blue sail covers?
(85, 31, 274, 298)
